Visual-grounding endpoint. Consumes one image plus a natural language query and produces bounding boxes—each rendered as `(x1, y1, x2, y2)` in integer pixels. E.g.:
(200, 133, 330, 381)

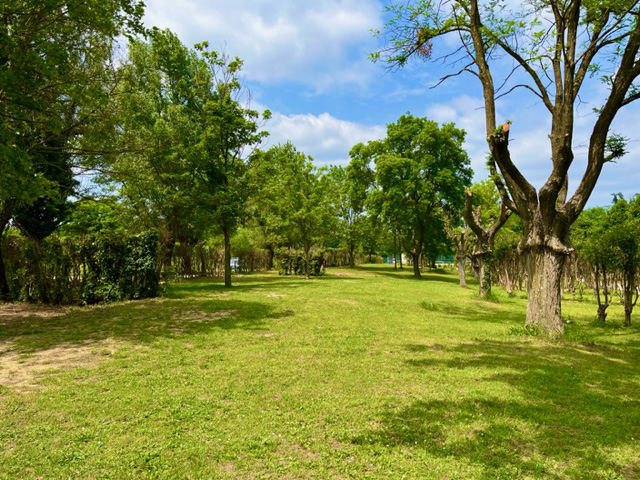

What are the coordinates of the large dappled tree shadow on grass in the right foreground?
(353, 341, 640, 478)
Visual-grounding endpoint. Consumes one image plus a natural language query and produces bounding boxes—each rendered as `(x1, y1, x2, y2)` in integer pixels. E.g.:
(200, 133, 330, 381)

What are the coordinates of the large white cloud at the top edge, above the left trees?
(145, 0, 381, 92)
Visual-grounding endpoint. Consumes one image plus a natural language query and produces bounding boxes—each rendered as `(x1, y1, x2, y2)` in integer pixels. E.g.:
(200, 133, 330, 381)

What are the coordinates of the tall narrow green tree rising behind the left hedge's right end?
(107, 29, 204, 273)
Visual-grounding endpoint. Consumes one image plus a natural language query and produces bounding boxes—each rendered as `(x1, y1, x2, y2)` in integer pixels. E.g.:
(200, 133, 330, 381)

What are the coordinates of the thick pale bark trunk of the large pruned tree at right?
(526, 247, 566, 336)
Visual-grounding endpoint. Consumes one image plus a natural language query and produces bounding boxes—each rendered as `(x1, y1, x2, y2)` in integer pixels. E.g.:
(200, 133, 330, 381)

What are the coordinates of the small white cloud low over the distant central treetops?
(265, 113, 386, 165)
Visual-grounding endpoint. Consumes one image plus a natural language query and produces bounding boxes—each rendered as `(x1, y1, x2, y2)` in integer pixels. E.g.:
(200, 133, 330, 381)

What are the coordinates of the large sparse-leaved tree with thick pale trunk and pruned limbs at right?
(374, 0, 640, 334)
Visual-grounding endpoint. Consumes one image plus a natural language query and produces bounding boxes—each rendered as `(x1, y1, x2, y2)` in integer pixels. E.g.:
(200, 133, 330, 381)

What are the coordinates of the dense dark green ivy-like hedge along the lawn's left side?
(2, 231, 160, 304)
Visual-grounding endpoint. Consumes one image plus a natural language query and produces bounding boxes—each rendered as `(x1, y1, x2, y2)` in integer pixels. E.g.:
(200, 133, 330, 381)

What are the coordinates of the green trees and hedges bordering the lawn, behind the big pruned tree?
(0, 0, 639, 333)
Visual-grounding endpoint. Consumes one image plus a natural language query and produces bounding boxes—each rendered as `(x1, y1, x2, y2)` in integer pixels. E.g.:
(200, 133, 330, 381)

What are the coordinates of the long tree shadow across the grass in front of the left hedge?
(0, 297, 293, 353)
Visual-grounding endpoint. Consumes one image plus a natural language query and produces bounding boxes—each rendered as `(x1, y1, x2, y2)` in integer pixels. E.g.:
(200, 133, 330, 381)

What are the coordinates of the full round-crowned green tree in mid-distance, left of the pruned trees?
(351, 114, 471, 277)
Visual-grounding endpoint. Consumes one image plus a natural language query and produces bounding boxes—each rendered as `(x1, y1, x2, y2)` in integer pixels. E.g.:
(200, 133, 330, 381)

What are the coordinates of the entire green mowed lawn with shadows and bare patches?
(0, 266, 640, 479)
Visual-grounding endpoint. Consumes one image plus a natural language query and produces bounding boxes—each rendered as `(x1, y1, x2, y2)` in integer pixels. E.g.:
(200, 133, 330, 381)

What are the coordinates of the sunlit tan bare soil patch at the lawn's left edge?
(0, 339, 125, 392)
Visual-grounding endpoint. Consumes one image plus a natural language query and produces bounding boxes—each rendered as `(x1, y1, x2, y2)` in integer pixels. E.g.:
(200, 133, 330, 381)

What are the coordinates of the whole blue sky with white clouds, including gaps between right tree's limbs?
(145, 0, 640, 206)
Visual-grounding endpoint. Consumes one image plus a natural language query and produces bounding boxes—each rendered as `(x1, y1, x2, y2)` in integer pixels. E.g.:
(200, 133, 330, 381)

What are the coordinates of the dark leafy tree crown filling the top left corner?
(0, 0, 143, 299)
